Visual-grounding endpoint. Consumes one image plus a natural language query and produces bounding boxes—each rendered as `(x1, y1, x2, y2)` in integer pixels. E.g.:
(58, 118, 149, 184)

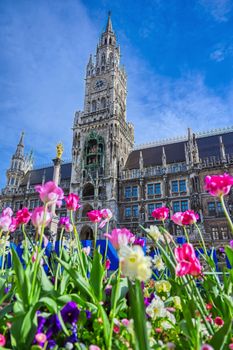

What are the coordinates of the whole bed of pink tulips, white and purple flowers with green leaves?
(0, 174, 233, 350)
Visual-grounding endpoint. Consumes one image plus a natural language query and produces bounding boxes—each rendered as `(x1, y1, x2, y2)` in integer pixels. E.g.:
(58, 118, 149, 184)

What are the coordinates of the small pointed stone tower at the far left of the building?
(6, 132, 25, 192)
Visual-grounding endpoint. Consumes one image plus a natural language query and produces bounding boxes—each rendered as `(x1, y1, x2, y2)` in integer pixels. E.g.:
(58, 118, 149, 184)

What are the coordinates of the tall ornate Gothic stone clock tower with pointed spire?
(71, 13, 134, 239)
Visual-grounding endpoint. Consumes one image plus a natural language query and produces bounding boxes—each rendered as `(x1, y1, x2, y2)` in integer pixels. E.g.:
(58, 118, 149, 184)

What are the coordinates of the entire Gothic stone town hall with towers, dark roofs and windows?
(0, 16, 233, 245)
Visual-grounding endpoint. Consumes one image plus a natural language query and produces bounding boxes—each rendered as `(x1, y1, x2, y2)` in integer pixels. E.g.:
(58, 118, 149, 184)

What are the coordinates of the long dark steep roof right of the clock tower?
(125, 131, 233, 170)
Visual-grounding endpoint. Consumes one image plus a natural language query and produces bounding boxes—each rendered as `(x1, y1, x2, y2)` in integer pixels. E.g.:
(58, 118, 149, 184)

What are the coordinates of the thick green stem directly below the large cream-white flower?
(128, 279, 150, 350)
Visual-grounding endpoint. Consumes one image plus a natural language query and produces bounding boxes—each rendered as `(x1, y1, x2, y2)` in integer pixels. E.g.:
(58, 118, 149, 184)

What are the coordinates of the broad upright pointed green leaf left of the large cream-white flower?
(90, 249, 104, 301)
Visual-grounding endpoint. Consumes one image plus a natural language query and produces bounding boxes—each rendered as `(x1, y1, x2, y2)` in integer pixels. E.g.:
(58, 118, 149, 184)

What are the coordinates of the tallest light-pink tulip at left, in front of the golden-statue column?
(35, 181, 64, 207)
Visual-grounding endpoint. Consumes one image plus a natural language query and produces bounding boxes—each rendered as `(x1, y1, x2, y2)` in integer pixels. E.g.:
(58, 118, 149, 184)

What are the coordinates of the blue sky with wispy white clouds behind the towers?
(0, 0, 233, 187)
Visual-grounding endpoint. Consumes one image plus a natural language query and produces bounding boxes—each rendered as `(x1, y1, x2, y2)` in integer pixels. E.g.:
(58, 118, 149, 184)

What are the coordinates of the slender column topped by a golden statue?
(50, 143, 64, 241)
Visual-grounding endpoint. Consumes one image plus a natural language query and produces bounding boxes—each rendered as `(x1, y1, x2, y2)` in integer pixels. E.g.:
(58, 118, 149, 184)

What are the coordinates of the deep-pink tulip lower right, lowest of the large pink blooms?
(175, 243, 201, 276)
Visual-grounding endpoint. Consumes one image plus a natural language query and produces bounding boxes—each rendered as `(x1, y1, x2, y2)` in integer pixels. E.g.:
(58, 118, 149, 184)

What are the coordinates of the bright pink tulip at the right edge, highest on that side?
(205, 174, 233, 197)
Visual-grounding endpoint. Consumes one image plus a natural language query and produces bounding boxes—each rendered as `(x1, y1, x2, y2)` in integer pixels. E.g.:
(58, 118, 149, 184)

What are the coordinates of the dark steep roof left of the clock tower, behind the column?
(21, 163, 71, 186)
